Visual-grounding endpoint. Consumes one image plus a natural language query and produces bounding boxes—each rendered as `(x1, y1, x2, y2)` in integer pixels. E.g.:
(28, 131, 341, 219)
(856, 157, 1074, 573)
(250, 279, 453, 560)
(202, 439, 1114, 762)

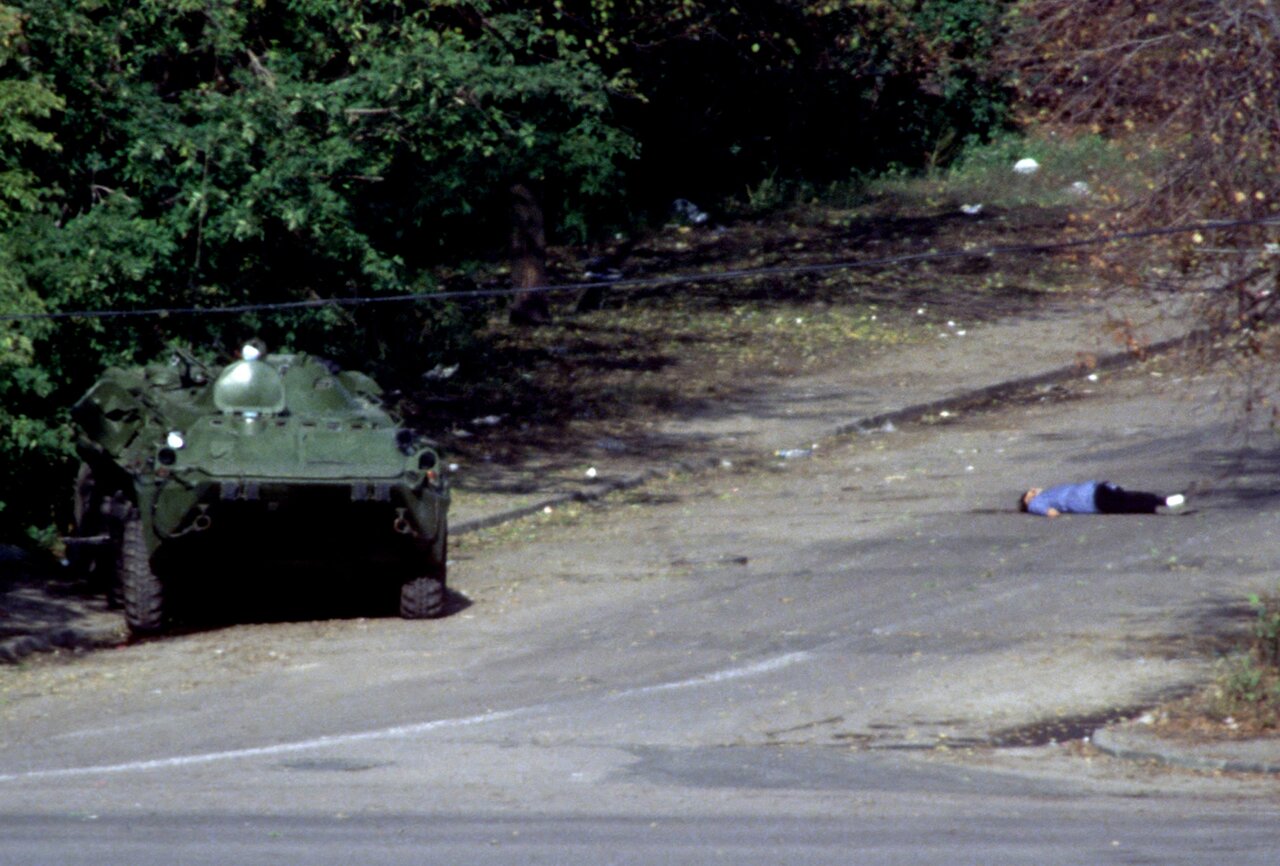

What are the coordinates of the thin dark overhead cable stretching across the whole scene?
(0, 215, 1280, 321)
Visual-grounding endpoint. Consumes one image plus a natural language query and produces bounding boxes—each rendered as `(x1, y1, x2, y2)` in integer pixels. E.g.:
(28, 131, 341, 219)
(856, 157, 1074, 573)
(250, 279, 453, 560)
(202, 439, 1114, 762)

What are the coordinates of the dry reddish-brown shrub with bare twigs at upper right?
(1002, 0, 1280, 365)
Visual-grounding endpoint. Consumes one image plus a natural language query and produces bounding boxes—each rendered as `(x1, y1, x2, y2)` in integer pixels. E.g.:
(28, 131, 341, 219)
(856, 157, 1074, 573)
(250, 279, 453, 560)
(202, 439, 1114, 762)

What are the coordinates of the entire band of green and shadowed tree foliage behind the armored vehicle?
(0, 0, 1007, 539)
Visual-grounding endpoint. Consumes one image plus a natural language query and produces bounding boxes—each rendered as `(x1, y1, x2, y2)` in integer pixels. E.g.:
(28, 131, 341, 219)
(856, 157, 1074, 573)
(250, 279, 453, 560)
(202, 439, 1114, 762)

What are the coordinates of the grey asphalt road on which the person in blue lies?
(0, 360, 1280, 865)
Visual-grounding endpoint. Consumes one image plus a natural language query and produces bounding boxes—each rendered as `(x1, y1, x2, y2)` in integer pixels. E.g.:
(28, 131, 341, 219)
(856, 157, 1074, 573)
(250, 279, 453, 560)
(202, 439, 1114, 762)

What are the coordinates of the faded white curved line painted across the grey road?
(0, 651, 812, 783)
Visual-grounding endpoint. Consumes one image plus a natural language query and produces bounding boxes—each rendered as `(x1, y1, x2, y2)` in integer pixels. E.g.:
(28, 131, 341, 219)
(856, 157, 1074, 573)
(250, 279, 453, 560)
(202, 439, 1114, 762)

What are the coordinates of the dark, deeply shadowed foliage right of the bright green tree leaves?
(529, 0, 1009, 206)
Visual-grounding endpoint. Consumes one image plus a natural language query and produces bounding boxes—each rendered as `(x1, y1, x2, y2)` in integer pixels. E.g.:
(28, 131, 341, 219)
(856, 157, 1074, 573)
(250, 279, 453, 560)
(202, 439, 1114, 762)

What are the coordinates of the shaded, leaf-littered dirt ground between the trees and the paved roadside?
(404, 205, 1121, 484)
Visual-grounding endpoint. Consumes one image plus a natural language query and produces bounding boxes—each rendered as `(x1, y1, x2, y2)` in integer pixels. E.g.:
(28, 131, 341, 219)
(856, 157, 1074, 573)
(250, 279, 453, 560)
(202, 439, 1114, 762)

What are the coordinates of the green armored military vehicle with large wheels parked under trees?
(68, 344, 449, 634)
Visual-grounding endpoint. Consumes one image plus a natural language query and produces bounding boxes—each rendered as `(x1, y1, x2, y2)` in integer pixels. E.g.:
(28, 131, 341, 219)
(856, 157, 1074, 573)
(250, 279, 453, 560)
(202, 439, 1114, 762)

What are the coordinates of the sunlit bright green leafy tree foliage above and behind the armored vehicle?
(0, 0, 635, 537)
